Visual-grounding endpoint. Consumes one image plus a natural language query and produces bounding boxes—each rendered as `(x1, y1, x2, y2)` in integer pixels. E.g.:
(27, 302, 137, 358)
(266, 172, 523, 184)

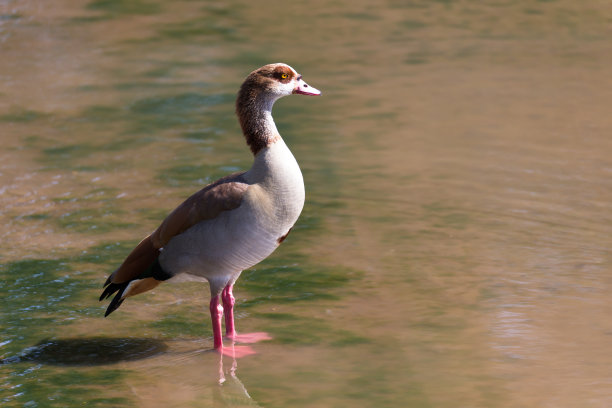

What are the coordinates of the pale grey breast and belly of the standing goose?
(159, 139, 304, 293)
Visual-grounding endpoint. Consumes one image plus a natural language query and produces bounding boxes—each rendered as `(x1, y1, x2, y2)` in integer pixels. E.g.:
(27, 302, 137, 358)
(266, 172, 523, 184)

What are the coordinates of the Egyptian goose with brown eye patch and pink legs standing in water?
(100, 63, 321, 351)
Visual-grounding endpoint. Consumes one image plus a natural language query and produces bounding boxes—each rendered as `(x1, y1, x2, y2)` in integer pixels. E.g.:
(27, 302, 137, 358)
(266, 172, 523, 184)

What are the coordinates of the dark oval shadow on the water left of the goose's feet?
(0, 337, 168, 366)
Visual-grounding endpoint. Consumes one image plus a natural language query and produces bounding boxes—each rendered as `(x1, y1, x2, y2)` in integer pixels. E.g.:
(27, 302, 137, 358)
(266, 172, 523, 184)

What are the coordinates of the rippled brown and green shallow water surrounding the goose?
(0, 0, 612, 407)
